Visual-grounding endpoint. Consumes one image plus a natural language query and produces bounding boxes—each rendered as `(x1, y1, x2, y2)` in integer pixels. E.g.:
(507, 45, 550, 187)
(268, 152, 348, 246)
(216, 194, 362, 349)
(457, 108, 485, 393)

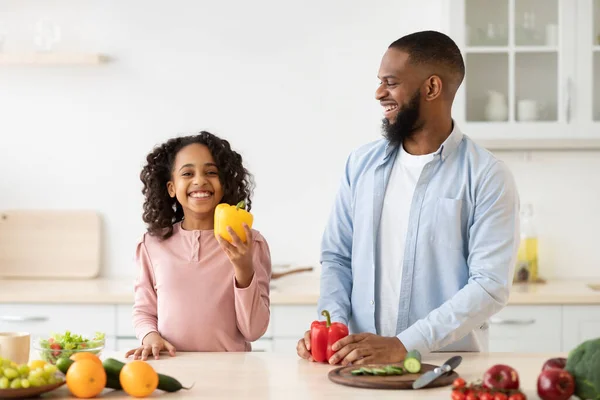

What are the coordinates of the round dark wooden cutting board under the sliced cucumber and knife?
(329, 364, 458, 390)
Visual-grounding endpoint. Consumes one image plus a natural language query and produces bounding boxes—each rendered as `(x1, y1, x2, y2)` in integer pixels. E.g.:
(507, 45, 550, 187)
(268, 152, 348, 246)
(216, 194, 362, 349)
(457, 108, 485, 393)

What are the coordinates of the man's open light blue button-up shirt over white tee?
(318, 123, 519, 353)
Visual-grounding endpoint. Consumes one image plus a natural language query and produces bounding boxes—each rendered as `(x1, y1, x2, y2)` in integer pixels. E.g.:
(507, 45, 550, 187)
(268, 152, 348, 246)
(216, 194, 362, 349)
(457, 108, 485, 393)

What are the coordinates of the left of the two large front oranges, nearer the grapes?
(65, 359, 106, 399)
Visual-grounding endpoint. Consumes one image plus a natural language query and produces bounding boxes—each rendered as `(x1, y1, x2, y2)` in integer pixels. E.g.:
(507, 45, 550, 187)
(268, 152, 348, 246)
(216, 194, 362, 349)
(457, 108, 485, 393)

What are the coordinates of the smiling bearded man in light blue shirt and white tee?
(297, 31, 519, 365)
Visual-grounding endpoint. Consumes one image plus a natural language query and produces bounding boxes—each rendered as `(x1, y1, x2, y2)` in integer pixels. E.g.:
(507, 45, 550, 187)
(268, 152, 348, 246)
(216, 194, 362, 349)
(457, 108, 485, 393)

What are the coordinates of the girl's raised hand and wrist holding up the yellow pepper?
(217, 223, 254, 288)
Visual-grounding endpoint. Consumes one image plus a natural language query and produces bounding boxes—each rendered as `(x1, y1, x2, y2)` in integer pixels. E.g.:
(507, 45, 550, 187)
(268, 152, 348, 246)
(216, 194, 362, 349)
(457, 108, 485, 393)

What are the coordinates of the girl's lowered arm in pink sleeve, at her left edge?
(133, 235, 158, 341)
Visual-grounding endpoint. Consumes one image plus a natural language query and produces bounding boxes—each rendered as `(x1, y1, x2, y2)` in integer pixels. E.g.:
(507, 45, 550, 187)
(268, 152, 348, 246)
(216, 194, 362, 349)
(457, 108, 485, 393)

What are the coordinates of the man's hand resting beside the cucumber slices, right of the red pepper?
(329, 333, 407, 366)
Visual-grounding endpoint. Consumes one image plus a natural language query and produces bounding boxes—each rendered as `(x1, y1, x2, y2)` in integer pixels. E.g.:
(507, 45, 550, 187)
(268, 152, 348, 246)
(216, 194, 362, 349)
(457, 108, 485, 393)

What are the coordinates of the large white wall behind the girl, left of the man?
(0, 0, 445, 276)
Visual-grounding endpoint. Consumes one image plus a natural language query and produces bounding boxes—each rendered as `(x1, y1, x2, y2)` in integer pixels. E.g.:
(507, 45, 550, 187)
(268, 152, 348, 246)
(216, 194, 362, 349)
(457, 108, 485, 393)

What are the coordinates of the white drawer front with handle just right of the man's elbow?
(489, 305, 563, 353)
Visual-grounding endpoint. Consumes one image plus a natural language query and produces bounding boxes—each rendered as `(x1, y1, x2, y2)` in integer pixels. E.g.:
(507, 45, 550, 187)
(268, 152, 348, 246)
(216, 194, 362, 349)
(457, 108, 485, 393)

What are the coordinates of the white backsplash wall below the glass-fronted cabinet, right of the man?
(496, 151, 600, 278)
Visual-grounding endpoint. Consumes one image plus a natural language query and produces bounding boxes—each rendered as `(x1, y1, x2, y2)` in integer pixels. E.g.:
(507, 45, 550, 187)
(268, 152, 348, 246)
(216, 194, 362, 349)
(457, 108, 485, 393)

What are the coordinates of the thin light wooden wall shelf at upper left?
(0, 52, 108, 65)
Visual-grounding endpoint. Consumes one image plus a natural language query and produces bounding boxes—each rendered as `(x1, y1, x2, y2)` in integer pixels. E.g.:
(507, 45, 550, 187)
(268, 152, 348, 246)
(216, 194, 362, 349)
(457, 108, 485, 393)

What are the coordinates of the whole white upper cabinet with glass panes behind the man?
(448, 0, 600, 149)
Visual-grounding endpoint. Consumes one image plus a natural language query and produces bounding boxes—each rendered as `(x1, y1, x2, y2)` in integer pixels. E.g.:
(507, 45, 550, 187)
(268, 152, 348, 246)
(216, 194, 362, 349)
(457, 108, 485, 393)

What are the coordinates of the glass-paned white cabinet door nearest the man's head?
(450, 0, 576, 139)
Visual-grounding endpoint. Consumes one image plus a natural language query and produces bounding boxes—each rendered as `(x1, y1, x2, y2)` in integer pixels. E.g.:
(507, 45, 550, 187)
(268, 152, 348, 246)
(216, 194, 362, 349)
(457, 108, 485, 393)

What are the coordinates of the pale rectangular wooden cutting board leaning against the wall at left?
(0, 210, 100, 279)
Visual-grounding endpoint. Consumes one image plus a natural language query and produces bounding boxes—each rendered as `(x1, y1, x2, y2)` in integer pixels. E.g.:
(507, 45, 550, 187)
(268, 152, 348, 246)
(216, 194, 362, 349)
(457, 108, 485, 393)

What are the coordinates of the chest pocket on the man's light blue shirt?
(432, 197, 464, 250)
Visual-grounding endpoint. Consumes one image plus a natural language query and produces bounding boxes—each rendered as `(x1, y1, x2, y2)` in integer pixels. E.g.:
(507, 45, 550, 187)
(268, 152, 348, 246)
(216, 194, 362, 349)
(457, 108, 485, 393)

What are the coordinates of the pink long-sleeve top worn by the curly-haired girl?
(133, 222, 271, 351)
